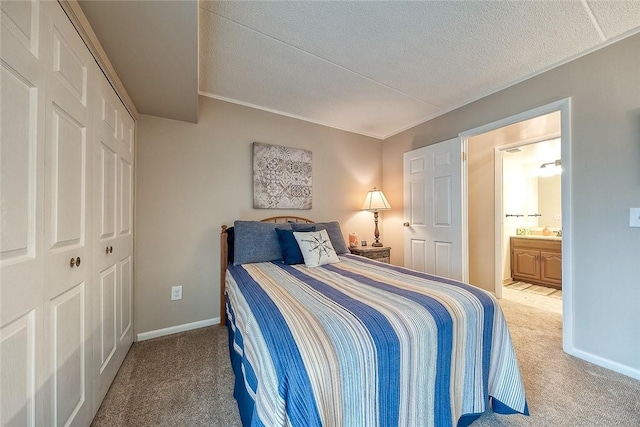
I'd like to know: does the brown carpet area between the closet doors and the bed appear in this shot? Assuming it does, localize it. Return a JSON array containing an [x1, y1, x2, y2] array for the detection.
[[92, 326, 240, 427]]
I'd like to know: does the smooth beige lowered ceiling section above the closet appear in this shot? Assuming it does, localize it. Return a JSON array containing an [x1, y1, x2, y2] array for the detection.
[[78, 0, 198, 123]]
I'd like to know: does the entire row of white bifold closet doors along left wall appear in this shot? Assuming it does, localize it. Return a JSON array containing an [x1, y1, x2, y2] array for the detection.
[[0, 0, 134, 426]]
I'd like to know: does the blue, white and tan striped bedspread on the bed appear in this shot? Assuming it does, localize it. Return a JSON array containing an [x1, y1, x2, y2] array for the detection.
[[227, 255, 528, 427]]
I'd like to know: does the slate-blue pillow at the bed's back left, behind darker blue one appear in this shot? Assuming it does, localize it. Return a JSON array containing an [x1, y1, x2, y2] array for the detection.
[[233, 221, 291, 265]]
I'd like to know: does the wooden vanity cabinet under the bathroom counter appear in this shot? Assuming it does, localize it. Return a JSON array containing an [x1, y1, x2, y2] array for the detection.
[[511, 237, 562, 289]]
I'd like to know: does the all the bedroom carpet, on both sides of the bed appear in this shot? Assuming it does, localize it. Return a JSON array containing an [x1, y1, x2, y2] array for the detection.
[[92, 299, 640, 427]]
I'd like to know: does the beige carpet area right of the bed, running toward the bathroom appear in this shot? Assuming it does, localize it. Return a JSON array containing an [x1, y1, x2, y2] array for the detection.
[[473, 299, 640, 427]]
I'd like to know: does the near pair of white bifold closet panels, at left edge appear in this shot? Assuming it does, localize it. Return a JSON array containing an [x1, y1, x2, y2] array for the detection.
[[0, 1, 97, 426]]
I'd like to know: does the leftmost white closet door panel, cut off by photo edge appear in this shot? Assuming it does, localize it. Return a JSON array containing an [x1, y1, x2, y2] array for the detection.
[[0, 1, 45, 426]]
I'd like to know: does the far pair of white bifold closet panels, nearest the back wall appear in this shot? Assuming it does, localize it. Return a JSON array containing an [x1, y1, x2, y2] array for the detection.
[[93, 78, 133, 405]]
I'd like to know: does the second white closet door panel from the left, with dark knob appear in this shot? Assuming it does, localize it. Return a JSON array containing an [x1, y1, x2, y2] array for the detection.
[[41, 2, 97, 426]]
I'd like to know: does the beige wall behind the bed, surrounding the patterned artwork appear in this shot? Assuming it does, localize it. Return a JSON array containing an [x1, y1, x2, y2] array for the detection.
[[135, 97, 384, 333]]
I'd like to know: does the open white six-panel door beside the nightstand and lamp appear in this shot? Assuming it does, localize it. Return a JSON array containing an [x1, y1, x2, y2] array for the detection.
[[404, 138, 463, 280]]
